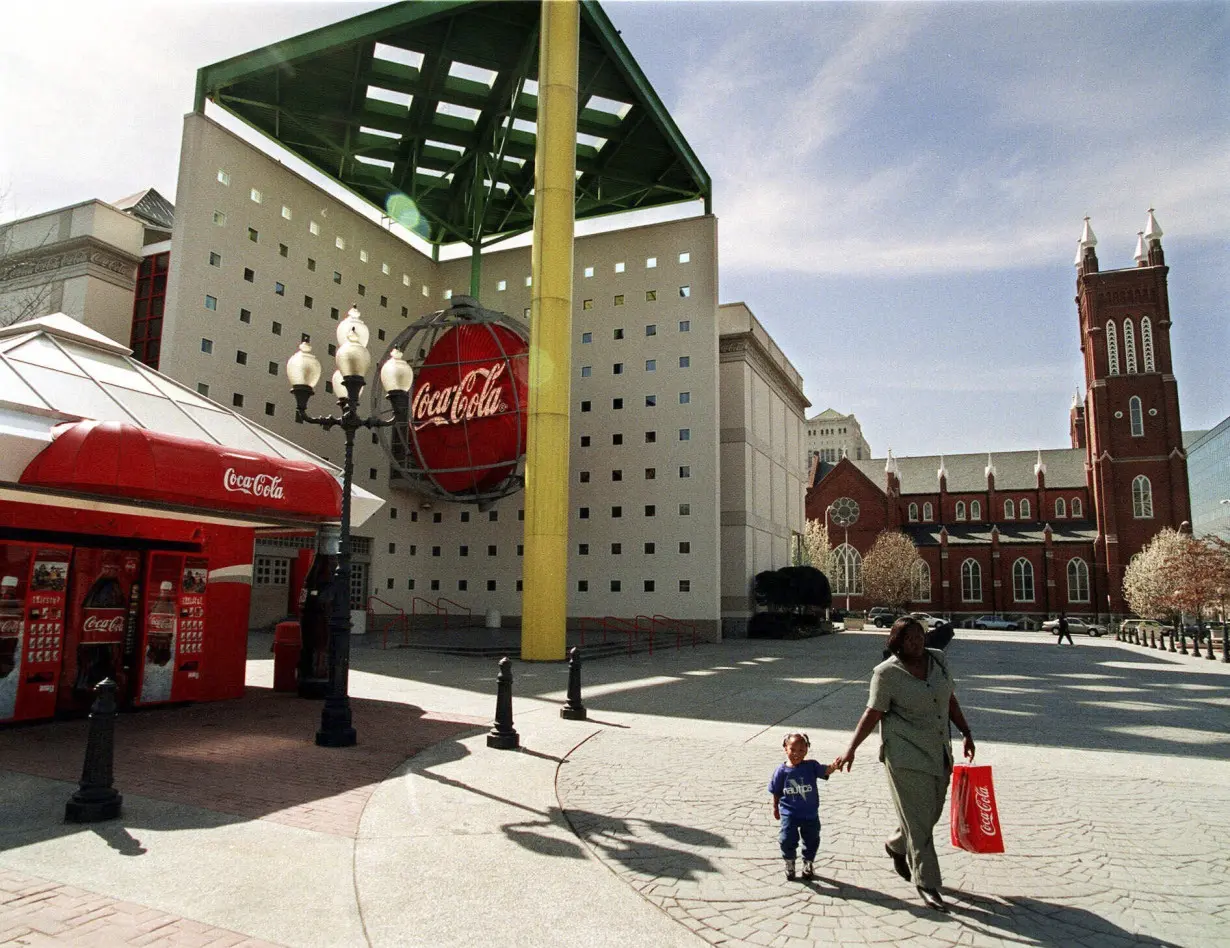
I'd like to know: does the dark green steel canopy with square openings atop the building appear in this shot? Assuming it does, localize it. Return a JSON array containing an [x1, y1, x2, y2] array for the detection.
[[196, 0, 712, 247]]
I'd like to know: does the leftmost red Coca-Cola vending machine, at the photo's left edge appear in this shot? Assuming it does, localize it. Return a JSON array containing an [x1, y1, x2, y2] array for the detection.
[[0, 543, 70, 722]]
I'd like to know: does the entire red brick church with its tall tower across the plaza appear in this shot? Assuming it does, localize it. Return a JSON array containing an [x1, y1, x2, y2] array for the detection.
[[807, 209, 1192, 621]]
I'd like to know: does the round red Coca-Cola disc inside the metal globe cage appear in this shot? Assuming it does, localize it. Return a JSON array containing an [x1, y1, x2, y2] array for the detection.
[[408, 323, 529, 494]]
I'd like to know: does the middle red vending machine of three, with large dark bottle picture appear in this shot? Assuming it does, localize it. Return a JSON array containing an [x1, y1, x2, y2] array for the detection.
[[57, 547, 141, 711]]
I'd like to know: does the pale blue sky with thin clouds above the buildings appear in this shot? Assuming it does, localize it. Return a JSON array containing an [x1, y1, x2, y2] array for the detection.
[[0, 0, 1230, 456]]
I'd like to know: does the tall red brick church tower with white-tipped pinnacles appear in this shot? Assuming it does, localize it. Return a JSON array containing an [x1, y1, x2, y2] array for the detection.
[[1074, 208, 1192, 614]]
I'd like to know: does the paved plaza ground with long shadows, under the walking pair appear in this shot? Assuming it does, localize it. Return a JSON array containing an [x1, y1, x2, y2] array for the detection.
[[0, 631, 1230, 947]]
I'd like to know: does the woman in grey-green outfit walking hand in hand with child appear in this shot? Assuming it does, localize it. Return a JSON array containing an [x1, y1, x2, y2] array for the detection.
[[833, 616, 974, 912]]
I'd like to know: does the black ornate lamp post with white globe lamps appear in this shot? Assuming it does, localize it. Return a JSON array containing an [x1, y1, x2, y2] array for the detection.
[[287, 306, 415, 748]]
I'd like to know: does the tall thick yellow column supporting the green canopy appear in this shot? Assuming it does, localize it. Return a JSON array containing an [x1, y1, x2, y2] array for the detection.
[[522, 0, 581, 662]]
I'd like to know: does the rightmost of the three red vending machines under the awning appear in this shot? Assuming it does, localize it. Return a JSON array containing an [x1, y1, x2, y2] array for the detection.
[[133, 552, 209, 705]]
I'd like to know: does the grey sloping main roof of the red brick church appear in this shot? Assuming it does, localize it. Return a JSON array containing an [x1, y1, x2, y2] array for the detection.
[[846, 448, 1086, 494]]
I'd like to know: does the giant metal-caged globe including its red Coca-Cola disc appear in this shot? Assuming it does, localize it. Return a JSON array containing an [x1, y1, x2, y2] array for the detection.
[[371, 296, 529, 503]]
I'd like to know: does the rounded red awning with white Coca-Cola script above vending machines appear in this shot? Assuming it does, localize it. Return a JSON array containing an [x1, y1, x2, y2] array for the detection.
[[21, 422, 342, 520]]
